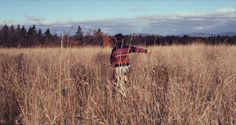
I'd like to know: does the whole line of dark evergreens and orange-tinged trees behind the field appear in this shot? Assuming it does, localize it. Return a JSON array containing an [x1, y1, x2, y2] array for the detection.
[[0, 25, 236, 48]]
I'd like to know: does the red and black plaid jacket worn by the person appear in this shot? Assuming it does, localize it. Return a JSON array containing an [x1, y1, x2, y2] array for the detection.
[[110, 46, 147, 67]]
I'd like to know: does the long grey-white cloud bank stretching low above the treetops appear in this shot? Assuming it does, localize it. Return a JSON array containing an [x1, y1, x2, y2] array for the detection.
[[2, 8, 236, 35]]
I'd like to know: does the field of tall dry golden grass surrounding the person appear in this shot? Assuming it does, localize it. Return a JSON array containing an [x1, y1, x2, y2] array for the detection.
[[0, 44, 236, 125]]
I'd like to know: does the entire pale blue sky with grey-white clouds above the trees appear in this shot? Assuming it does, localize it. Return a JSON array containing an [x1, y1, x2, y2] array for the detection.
[[0, 0, 236, 35]]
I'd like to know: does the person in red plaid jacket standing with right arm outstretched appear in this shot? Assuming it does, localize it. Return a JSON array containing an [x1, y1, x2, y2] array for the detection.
[[110, 33, 147, 95]]
